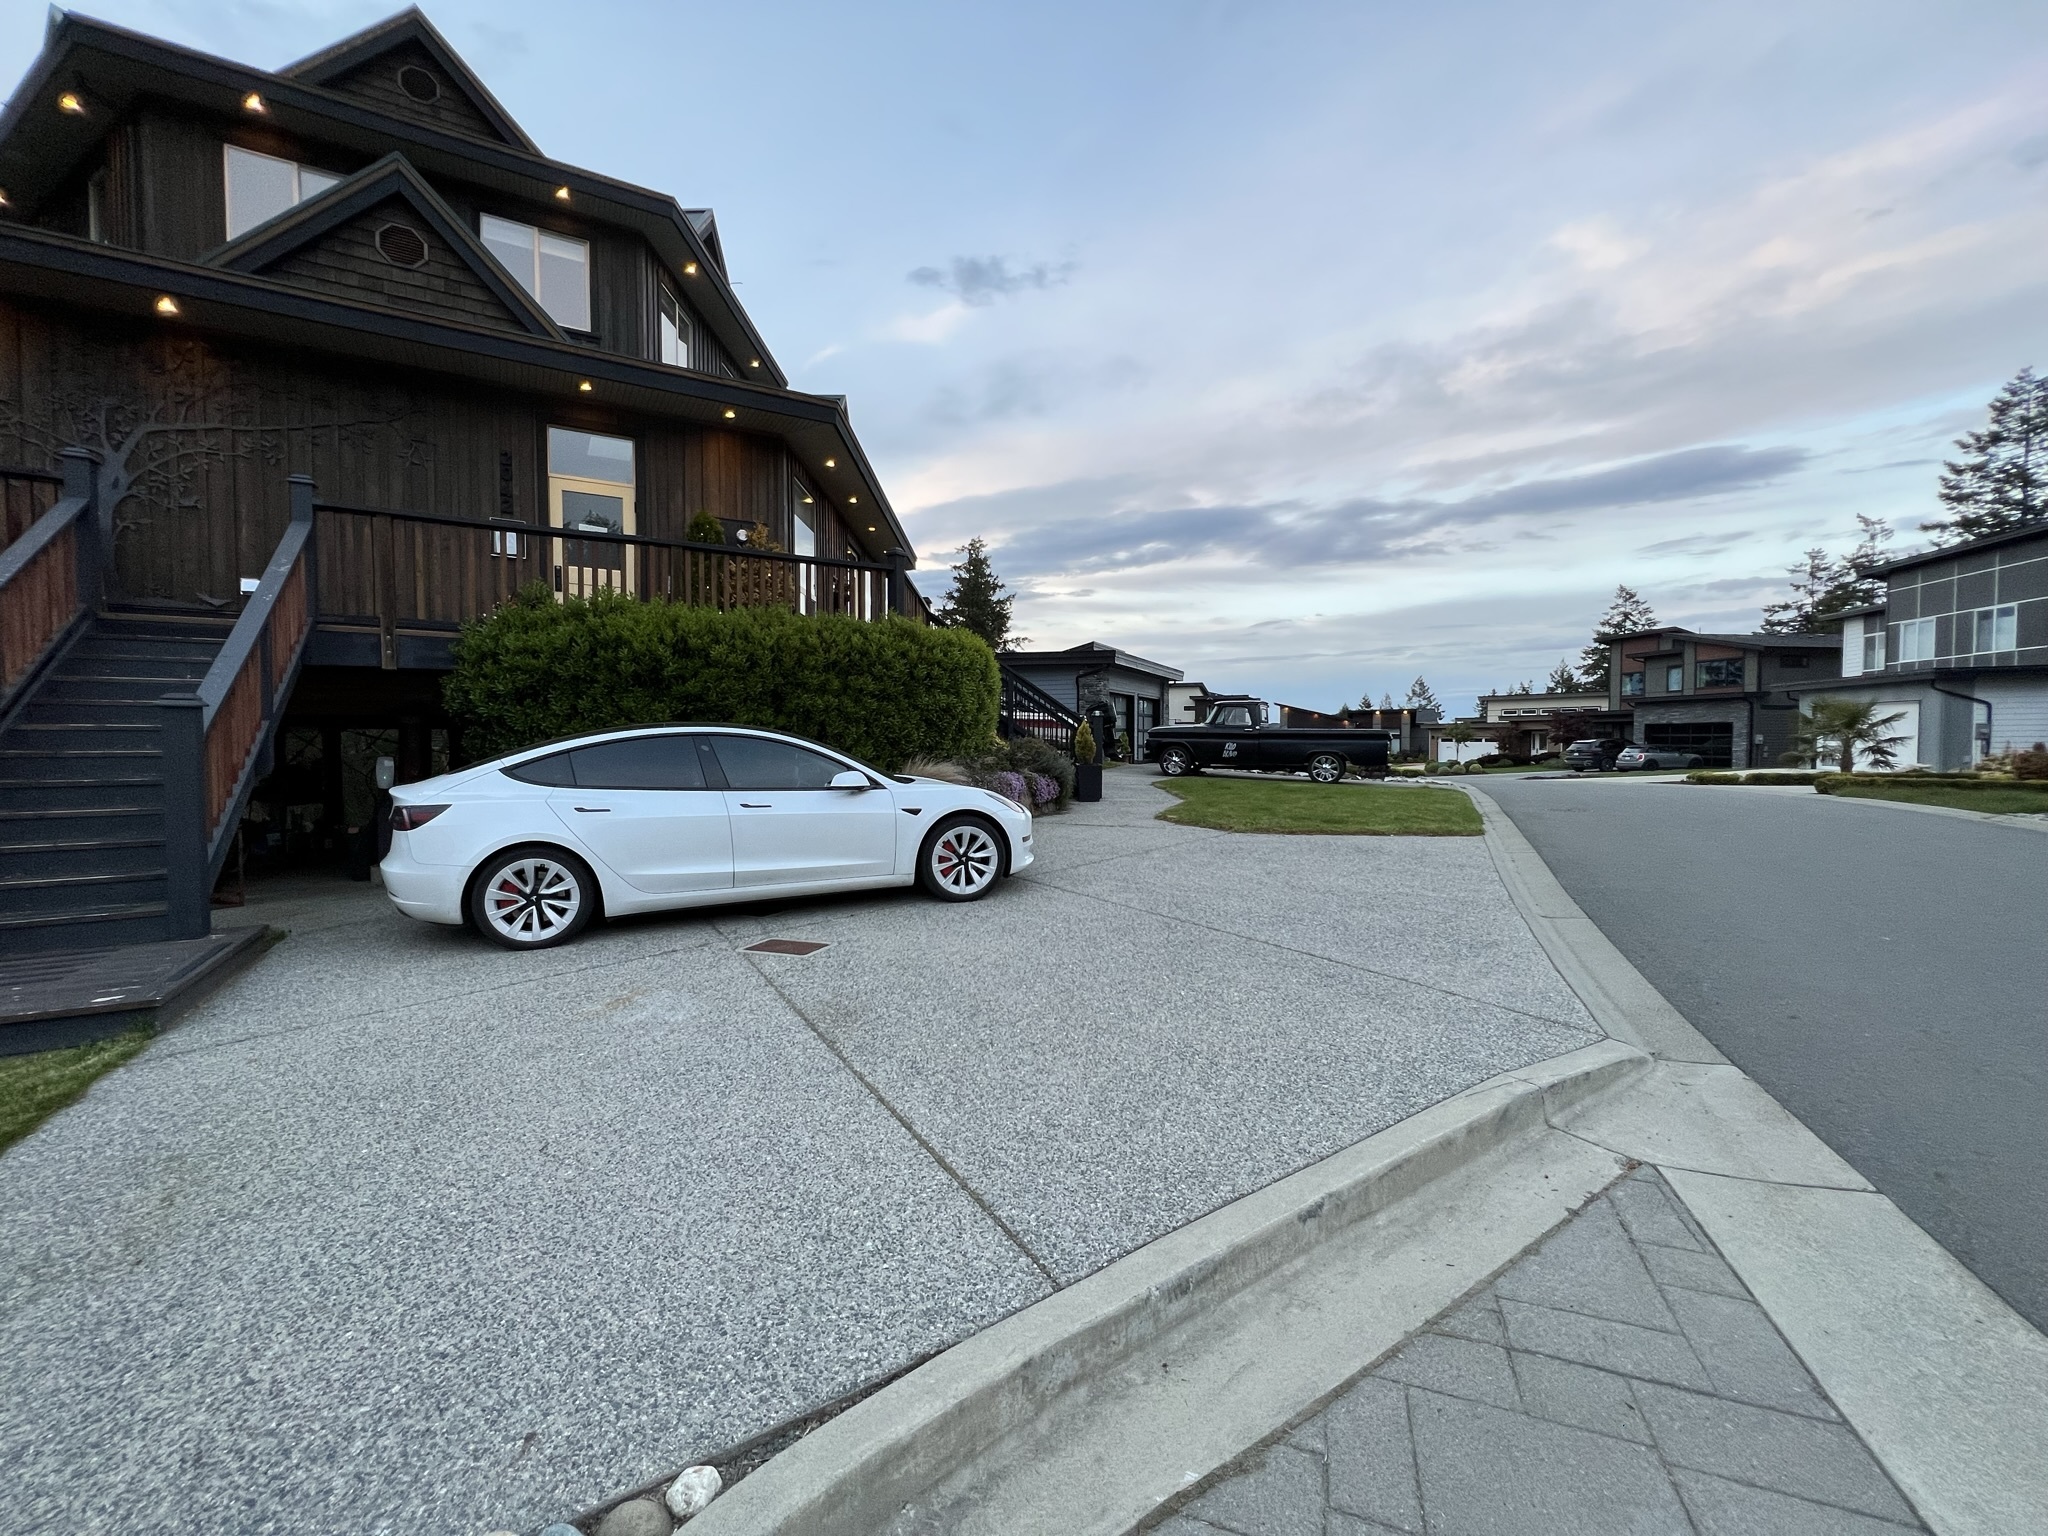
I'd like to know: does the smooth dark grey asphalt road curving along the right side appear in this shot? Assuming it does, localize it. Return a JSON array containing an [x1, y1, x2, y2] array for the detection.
[[1485, 776, 2048, 1329]]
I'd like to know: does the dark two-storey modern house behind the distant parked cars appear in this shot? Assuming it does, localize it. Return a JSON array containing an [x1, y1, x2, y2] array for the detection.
[[1606, 627, 1841, 768]]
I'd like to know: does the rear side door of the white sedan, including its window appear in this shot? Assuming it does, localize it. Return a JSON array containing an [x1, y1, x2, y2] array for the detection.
[[547, 735, 733, 895]]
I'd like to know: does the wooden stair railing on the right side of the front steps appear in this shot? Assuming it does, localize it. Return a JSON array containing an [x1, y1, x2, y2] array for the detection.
[[158, 475, 319, 938]]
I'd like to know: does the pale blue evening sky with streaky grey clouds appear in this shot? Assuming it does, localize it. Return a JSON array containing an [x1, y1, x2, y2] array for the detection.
[[0, 0, 2048, 711]]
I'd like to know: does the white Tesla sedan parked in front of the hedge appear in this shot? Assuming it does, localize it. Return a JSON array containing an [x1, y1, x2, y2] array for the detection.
[[381, 725, 1032, 950]]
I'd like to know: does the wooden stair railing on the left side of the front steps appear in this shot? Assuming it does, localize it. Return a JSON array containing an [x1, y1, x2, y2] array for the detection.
[[0, 449, 104, 719]]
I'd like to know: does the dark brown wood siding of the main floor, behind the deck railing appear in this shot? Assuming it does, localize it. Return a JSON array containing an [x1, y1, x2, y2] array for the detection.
[[0, 301, 848, 618]]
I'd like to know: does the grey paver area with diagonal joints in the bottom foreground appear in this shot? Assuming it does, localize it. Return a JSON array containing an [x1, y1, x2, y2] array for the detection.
[[1153, 1167, 1925, 1536]]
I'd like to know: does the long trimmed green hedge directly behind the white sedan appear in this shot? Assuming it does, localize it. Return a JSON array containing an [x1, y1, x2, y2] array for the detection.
[[442, 584, 1001, 770]]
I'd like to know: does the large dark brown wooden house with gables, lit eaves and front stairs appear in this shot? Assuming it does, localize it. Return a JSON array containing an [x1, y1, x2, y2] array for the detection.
[[0, 10, 922, 954]]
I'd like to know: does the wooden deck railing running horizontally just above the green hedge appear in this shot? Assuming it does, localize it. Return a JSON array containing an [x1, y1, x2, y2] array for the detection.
[[315, 502, 930, 668]]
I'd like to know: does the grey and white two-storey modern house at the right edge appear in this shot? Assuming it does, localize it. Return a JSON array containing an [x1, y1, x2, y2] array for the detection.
[[1796, 524, 2048, 770]]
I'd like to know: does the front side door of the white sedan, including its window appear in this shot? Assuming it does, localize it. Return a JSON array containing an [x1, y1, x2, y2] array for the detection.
[[711, 735, 903, 887]]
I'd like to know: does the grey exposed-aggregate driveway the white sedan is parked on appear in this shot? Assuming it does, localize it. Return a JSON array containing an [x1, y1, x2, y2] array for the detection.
[[0, 770, 1595, 1536]]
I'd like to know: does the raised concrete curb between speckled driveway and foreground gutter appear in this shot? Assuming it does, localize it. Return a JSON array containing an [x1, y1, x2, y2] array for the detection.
[[692, 1040, 1649, 1536]]
